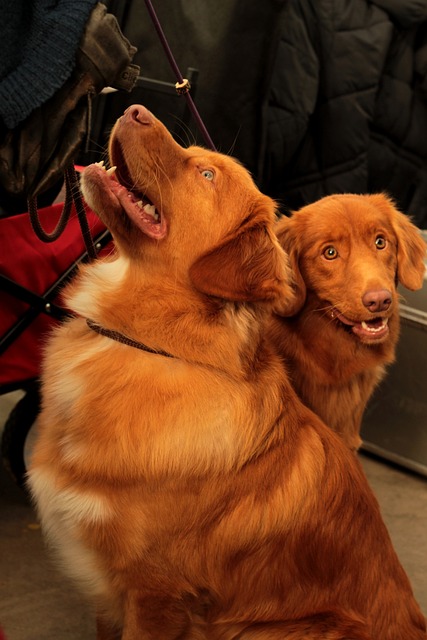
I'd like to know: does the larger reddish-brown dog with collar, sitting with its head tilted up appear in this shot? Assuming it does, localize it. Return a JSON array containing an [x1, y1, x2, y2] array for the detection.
[[29, 105, 427, 640]]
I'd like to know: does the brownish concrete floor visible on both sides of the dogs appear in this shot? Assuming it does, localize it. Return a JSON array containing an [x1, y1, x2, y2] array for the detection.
[[0, 394, 427, 640]]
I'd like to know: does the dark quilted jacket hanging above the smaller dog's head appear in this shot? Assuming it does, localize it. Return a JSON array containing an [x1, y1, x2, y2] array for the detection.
[[259, 0, 427, 228]]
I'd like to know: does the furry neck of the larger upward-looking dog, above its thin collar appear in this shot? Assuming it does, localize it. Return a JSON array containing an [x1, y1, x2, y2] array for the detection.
[[64, 259, 268, 376]]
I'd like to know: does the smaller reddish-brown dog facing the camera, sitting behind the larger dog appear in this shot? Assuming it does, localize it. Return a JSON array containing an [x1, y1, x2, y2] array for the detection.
[[271, 194, 426, 449]]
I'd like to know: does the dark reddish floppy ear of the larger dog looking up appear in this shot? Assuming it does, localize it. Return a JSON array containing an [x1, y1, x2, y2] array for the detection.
[[190, 216, 300, 311]]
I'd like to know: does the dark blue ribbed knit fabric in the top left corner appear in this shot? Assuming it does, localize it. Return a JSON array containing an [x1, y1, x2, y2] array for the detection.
[[0, 0, 96, 129]]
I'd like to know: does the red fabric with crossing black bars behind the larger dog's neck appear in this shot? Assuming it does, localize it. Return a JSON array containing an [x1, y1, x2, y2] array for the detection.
[[0, 203, 112, 393]]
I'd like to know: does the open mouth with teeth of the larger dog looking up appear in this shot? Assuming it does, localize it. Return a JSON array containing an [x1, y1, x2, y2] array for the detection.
[[95, 145, 167, 240]]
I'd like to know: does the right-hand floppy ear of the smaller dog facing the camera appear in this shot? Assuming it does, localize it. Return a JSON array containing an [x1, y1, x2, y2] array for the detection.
[[372, 194, 426, 291]]
